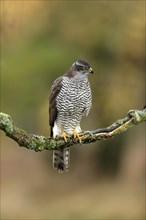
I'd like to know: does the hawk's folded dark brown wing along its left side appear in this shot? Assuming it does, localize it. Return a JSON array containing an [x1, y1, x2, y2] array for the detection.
[[49, 77, 62, 137]]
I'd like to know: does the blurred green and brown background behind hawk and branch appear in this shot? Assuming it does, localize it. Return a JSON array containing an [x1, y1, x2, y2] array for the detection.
[[1, 0, 145, 220]]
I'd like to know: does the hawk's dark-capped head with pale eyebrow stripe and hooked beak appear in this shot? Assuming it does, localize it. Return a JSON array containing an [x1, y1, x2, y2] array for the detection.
[[65, 60, 93, 78]]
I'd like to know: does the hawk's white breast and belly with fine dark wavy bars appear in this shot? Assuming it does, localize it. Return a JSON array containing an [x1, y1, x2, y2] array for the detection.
[[53, 77, 92, 137]]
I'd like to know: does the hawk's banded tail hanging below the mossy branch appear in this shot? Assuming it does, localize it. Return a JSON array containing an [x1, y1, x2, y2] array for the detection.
[[53, 148, 70, 173]]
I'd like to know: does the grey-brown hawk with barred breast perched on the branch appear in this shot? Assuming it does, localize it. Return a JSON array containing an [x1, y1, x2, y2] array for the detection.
[[49, 60, 93, 172]]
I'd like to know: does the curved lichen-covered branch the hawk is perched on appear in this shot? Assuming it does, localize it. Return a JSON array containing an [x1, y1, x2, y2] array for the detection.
[[0, 108, 146, 151]]
